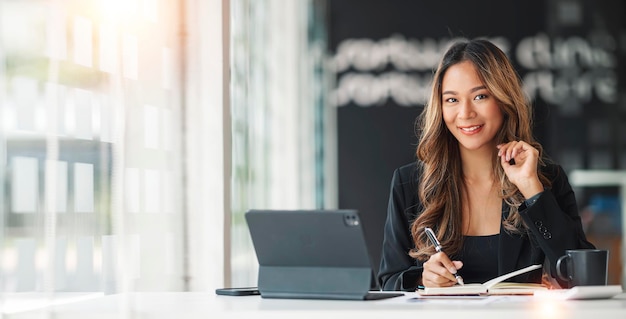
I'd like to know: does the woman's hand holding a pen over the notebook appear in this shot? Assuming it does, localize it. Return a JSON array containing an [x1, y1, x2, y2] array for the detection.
[[422, 252, 463, 287]]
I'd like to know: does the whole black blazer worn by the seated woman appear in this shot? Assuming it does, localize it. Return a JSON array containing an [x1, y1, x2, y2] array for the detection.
[[377, 163, 594, 291]]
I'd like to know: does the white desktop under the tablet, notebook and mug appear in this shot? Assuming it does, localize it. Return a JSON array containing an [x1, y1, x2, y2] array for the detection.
[[2, 292, 626, 319]]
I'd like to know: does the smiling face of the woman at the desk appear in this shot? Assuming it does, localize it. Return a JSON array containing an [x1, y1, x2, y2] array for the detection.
[[441, 61, 504, 154]]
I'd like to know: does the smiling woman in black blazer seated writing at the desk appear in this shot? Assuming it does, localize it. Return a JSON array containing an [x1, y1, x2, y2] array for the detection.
[[378, 39, 593, 291]]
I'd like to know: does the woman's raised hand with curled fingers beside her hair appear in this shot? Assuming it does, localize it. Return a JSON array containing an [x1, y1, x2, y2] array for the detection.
[[497, 141, 543, 198]]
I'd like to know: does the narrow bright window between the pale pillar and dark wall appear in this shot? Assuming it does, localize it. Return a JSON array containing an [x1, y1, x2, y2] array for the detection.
[[231, 0, 336, 286]]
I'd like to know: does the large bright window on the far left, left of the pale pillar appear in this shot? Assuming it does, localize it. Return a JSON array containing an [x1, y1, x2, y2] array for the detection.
[[0, 0, 184, 311]]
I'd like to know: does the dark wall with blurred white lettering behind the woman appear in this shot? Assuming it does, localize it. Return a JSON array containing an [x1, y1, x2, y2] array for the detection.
[[328, 0, 626, 288]]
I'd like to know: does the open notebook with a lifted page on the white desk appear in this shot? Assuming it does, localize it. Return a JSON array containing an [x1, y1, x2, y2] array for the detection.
[[417, 265, 548, 295]]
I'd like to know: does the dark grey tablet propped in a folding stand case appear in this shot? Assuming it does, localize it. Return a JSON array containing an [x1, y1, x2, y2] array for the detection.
[[245, 210, 403, 300]]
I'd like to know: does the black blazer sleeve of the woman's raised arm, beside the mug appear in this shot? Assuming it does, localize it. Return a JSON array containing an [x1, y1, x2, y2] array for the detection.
[[520, 165, 595, 286]]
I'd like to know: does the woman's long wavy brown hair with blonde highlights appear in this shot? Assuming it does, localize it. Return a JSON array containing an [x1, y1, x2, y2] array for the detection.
[[409, 39, 550, 261]]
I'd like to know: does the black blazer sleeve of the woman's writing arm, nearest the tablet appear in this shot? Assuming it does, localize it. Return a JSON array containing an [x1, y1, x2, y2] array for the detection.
[[377, 165, 422, 291]]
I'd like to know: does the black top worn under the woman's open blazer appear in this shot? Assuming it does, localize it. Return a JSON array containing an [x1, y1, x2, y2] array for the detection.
[[454, 234, 500, 284]]
